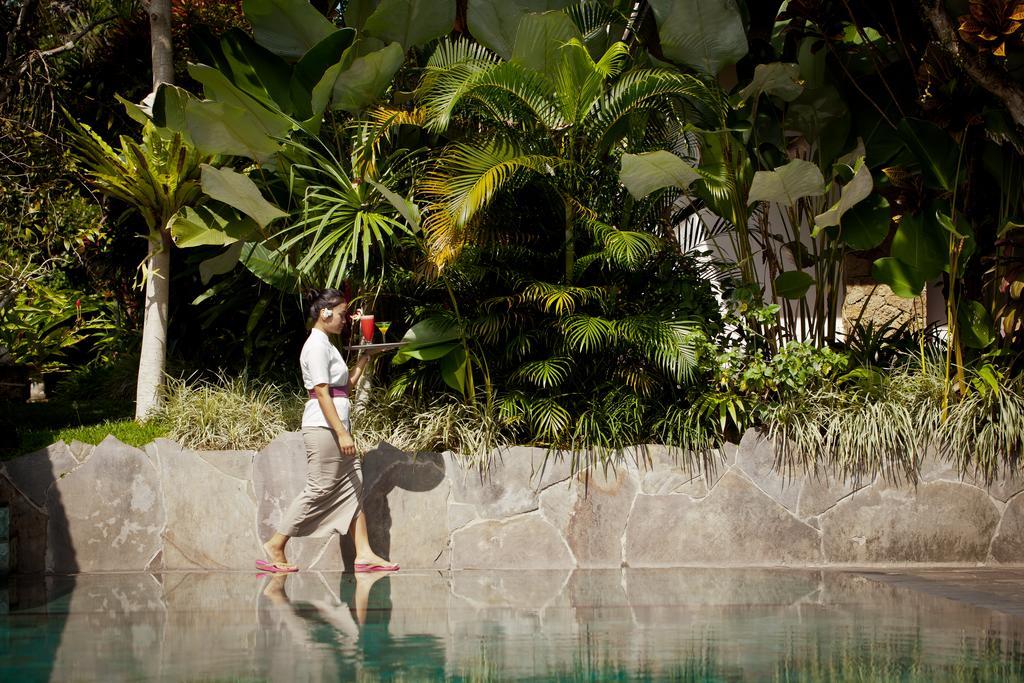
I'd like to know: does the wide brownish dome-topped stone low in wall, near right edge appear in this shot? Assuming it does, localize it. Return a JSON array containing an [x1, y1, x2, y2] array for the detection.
[[820, 481, 999, 563]]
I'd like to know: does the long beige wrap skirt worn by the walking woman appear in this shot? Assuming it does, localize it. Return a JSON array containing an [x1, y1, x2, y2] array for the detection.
[[278, 427, 362, 537]]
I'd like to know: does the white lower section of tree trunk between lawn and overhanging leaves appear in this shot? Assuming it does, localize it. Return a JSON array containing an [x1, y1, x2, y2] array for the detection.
[[135, 231, 171, 420]]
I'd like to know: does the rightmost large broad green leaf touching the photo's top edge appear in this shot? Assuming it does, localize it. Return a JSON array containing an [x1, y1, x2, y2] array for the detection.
[[648, 0, 748, 76]]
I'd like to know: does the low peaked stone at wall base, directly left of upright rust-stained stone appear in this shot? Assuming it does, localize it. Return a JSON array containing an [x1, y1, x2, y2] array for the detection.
[[452, 512, 575, 569]]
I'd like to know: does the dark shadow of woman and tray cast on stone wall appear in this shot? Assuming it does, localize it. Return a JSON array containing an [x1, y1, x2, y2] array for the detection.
[[341, 442, 446, 571]]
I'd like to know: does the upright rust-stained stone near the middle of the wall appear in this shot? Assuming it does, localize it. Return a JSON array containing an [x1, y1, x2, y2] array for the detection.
[[560, 465, 639, 567]]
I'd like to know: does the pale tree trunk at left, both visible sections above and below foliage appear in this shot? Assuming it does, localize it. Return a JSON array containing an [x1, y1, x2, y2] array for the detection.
[[135, 0, 174, 420]]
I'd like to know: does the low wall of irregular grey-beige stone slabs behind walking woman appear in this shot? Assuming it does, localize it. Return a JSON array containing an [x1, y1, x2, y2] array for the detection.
[[0, 431, 1024, 573]]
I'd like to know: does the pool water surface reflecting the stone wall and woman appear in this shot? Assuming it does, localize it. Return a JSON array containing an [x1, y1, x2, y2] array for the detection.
[[0, 569, 1024, 681]]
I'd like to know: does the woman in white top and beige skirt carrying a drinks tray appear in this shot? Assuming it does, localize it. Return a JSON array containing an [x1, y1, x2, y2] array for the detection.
[[256, 289, 398, 572]]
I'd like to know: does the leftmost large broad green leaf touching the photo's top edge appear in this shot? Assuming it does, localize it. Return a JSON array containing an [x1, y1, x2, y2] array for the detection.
[[242, 0, 338, 60]]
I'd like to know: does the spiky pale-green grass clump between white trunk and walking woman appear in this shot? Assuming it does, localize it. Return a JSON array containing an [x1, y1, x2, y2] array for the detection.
[[154, 375, 303, 451]]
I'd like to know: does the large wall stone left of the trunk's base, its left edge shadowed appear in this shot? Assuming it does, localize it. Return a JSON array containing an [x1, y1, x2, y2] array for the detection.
[[46, 436, 165, 573]]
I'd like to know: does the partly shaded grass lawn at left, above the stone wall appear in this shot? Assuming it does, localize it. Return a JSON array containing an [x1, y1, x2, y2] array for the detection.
[[0, 399, 167, 460]]
